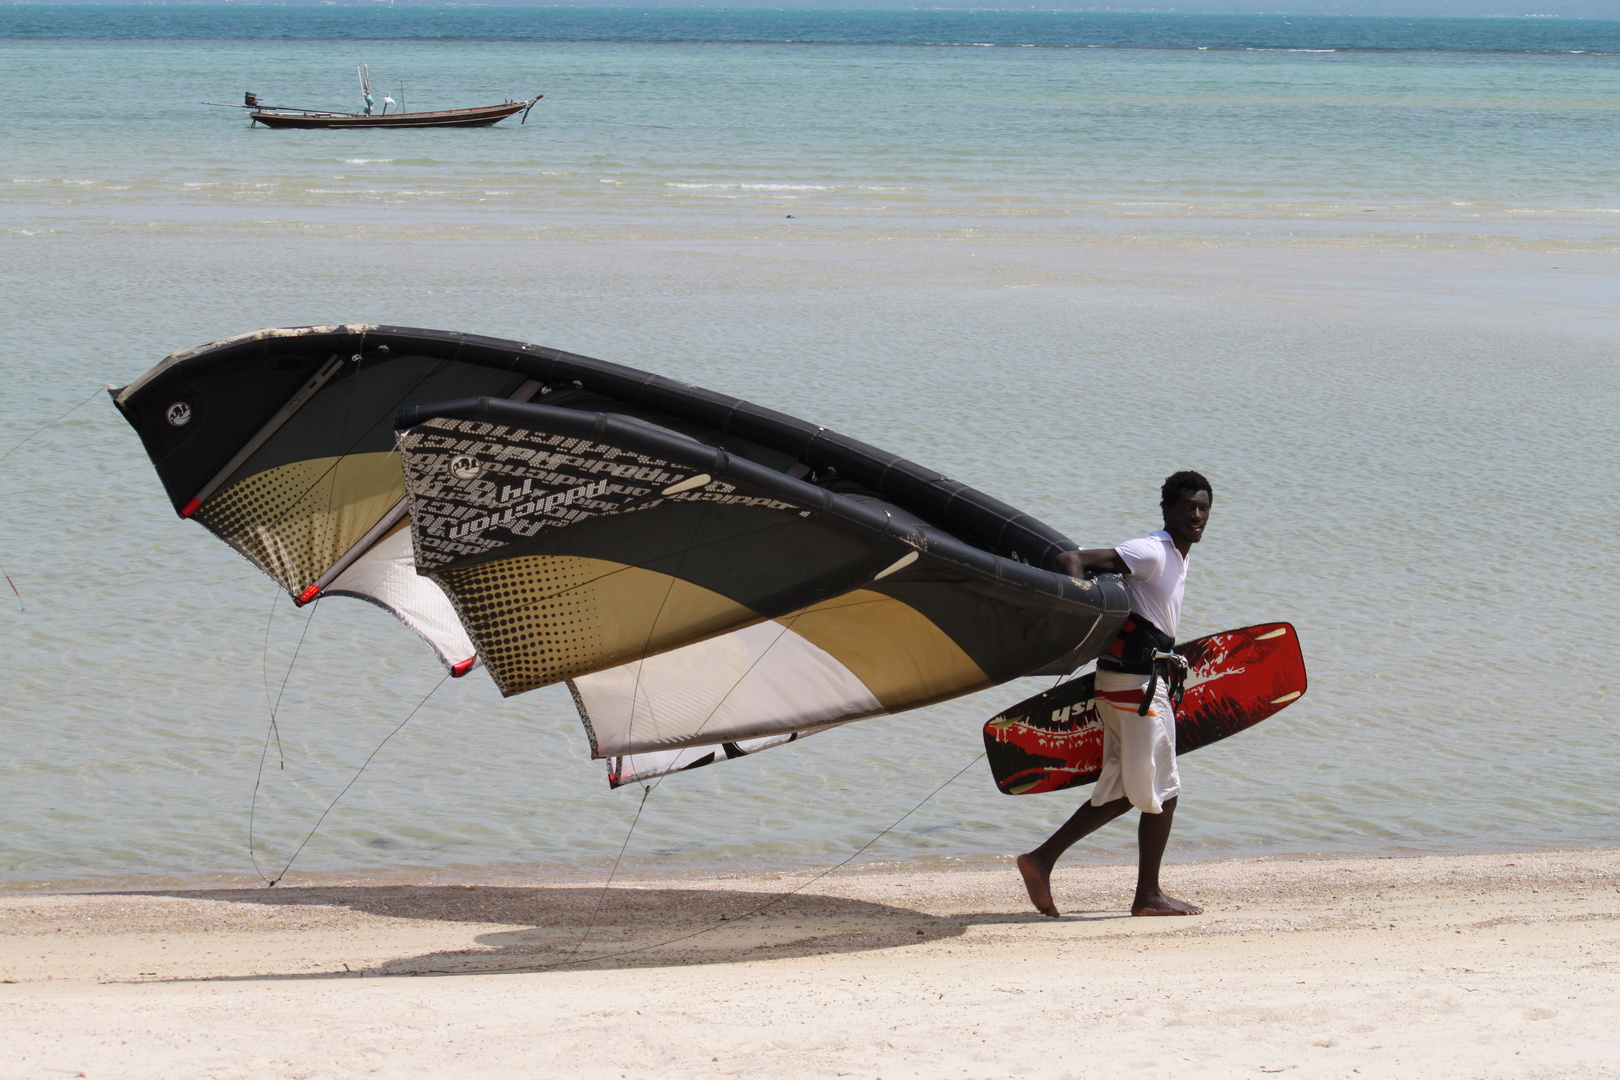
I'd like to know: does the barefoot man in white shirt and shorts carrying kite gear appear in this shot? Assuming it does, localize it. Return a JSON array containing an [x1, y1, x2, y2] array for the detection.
[[1017, 471, 1215, 918]]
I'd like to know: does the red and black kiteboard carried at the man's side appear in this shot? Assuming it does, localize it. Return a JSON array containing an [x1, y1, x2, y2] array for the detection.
[[985, 622, 1306, 795]]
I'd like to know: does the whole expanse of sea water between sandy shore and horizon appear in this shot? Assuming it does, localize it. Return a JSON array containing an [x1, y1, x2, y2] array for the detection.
[[0, 5, 1620, 887]]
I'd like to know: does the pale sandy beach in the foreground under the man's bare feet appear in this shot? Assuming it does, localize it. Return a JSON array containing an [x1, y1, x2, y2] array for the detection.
[[0, 850, 1620, 1078]]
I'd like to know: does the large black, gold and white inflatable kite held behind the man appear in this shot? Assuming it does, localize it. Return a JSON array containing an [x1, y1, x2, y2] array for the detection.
[[113, 325, 1129, 785]]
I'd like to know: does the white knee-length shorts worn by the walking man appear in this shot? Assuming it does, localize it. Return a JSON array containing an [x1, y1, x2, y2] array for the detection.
[[1092, 670, 1181, 814]]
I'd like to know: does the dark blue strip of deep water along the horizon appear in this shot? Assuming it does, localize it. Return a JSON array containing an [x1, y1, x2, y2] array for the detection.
[[0, 3, 1620, 53]]
